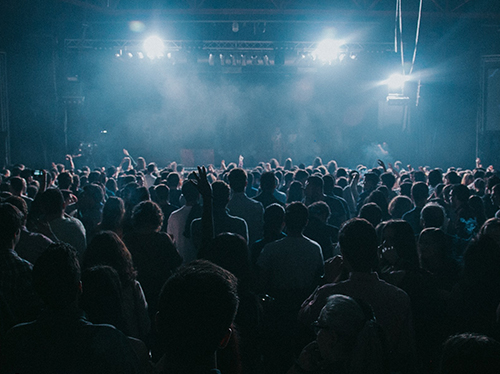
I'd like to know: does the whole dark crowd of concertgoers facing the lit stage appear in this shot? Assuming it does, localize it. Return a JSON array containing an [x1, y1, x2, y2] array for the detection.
[[0, 150, 500, 374]]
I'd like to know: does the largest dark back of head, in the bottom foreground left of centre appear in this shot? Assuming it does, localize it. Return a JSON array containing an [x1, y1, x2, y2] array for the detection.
[[157, 260, 238, 363]]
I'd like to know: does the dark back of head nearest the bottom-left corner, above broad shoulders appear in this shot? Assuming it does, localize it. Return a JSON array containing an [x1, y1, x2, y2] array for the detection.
[[33, 243, 80, 309]]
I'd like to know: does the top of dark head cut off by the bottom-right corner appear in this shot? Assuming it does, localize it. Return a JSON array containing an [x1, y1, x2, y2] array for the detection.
[[441, 333, 500, 374]]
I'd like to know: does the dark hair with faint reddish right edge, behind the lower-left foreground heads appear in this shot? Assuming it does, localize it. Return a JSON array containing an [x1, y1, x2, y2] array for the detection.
[[83, 231, 137, 287]]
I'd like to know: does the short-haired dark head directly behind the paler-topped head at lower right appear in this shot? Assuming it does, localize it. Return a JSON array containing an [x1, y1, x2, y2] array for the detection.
[[339, 218, 378, 272]]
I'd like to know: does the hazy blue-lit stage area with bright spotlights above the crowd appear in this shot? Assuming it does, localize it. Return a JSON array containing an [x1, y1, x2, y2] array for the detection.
[[0, 0, 500, 167]]
